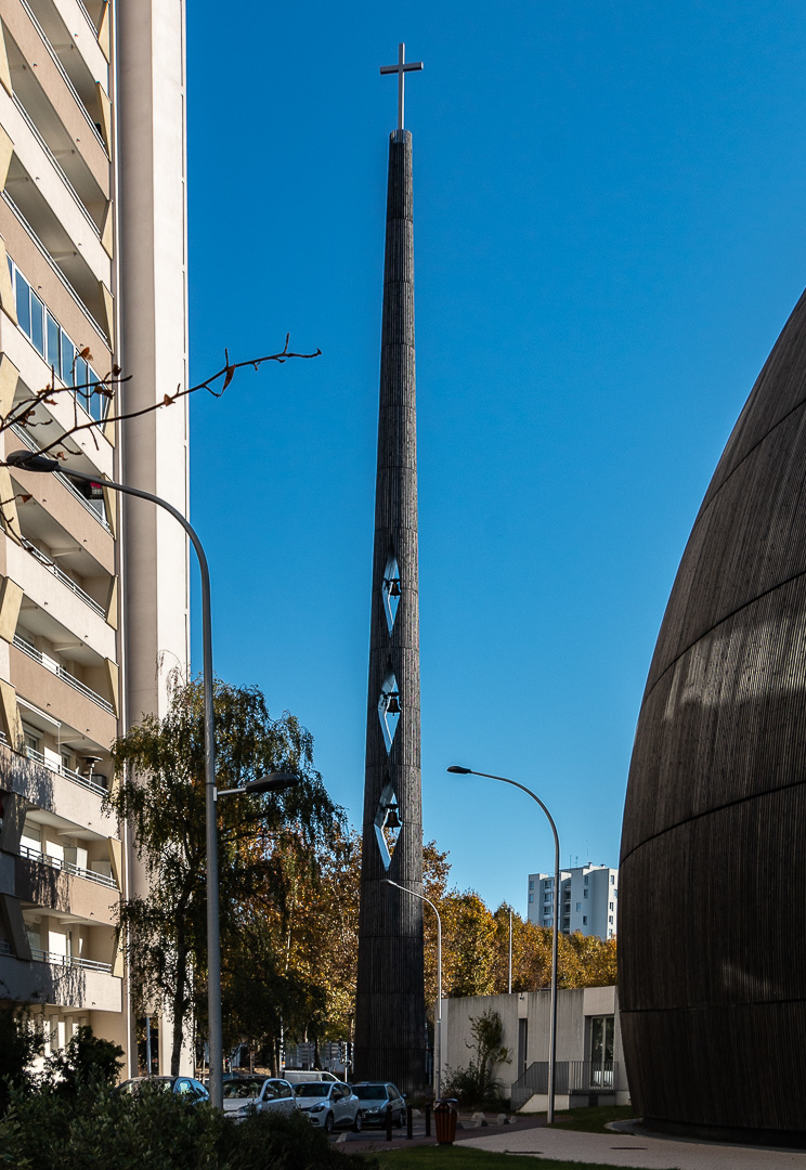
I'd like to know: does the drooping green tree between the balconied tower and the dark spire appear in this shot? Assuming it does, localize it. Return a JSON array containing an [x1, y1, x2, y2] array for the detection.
[[105, 681, 340, 1074]]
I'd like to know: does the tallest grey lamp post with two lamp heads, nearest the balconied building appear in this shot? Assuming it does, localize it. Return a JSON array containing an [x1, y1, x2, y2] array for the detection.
[[6, 450, 285, 1109]]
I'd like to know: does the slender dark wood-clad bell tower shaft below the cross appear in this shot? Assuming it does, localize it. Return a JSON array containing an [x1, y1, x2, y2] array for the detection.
[[354, 131, 426, 1092]]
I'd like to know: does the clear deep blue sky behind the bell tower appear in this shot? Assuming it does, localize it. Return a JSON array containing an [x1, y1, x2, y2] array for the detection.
[[188, 0, 806, 913]]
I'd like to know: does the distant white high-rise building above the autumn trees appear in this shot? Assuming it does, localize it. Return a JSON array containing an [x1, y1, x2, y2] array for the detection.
[[526, 861, 619, 938]]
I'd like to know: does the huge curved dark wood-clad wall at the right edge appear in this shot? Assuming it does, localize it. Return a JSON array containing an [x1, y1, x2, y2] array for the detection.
[[619, 287, 806, 1137]]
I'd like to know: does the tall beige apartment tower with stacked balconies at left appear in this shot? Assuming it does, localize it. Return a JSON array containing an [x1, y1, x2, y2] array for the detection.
[[0, 0, 188, 1073]]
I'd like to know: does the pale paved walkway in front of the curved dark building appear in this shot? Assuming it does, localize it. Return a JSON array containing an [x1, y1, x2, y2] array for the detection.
[[455, 1126, 806, 1170]]
